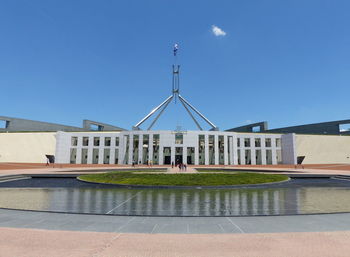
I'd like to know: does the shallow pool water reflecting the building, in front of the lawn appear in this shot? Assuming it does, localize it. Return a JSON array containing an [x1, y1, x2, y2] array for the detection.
[[0, 187, 350, 216]]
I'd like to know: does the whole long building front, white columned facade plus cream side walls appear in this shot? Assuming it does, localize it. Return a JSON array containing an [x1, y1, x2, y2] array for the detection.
[[0, 117, 350, 165]]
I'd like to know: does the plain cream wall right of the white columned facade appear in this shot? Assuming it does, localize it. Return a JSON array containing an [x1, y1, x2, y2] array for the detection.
[[296, 135, 350, 164]]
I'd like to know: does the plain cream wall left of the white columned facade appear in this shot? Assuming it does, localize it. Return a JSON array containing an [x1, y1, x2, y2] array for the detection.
[[0, 132, 56, 163]]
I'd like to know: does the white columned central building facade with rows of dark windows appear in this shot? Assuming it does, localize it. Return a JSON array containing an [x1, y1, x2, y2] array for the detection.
[[55, 130, 296, 165]]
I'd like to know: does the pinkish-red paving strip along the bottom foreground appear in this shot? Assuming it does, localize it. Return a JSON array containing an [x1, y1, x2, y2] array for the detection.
[[0, 228, 350, 257]]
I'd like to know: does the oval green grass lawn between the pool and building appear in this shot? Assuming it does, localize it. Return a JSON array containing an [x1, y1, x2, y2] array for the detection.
[[78, 172, 288, 186]]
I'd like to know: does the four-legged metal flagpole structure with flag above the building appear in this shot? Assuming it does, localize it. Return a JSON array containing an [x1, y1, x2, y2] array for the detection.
[[132, 44, 219, 130]]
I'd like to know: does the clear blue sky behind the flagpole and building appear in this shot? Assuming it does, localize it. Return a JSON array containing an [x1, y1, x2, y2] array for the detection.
[[0, 0, 350, 130]]
